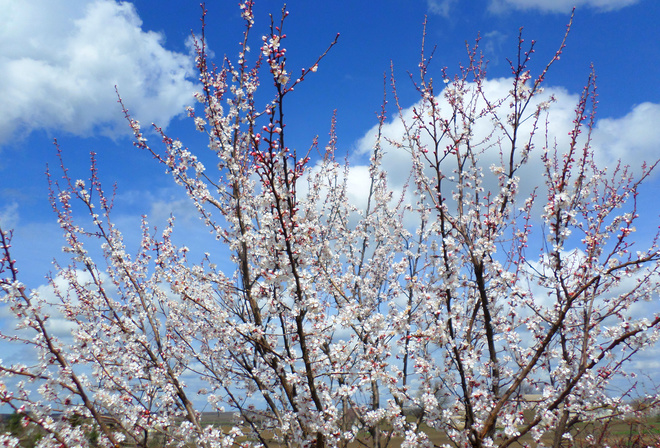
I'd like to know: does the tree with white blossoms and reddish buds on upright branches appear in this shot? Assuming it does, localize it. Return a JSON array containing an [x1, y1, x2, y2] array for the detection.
[[0, 1, 660, 448]]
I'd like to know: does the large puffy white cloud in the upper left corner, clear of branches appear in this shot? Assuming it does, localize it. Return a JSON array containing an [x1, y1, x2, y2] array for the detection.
[[0, 0, 194, 144]]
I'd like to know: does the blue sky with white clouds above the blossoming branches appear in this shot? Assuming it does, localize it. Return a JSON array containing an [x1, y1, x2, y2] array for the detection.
[[0, 0, 660, 360]]
